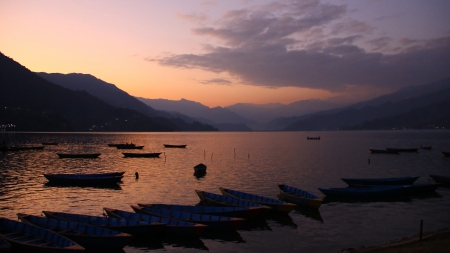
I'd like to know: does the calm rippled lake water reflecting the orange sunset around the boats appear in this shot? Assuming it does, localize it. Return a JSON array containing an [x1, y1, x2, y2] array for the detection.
[[0, 131, 450, 252]]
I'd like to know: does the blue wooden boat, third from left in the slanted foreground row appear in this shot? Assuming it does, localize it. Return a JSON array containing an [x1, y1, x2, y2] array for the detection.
[[42, 211, 166, 235]]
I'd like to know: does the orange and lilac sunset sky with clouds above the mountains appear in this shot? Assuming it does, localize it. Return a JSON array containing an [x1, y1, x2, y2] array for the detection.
[[0, 0, 450, 107]]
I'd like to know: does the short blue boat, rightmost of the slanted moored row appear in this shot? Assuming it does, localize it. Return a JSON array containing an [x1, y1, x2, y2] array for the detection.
[[278, 183, 323, 208]]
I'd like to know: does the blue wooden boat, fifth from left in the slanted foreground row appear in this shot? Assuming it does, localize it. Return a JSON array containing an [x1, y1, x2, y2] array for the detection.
[[131, 205, 246, 229]]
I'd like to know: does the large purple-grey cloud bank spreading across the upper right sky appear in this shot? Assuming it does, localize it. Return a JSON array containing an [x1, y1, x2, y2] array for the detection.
[[153, 0, 450, 92]]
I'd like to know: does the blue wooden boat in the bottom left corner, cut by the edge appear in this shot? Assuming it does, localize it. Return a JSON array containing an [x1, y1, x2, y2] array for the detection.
[[0, 215, 84, 253]]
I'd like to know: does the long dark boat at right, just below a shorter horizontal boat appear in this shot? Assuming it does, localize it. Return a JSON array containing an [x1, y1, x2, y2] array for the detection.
[[319, 185, 411, 198]]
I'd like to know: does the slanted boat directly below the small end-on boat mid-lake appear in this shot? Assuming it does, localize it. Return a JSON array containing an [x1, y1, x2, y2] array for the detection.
[[195, 190, 272, 213]]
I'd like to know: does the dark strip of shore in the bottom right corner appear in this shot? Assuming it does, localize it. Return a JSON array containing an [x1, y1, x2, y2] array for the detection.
[[340, 229, 450, 253]]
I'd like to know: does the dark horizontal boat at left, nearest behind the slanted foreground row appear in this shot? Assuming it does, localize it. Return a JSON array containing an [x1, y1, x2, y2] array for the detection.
[[44, 172, 125, 185]]
